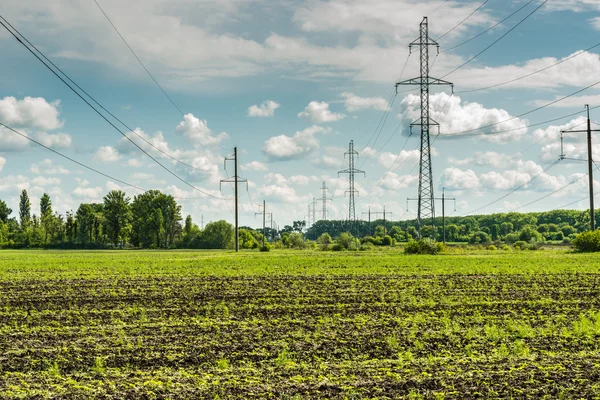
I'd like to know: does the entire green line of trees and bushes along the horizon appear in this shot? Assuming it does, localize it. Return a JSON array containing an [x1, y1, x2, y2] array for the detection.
[[0, 186, 598, 249]]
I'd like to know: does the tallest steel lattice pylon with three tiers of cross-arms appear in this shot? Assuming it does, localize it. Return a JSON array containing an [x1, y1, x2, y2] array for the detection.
[[396, 17, 454, 237]]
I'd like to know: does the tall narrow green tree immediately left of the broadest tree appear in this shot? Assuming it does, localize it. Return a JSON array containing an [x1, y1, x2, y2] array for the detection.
[[104, 190, 132, 247]]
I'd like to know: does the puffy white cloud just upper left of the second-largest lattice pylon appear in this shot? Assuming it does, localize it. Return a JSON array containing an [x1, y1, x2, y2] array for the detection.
[[263, 125, 329, 160]]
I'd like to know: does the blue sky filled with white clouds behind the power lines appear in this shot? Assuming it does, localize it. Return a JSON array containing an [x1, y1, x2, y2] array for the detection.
[[0, 0, 600, 226]]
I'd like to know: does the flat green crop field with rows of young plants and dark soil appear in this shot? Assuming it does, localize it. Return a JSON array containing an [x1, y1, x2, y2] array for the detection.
[[0, 250, 600, 399]]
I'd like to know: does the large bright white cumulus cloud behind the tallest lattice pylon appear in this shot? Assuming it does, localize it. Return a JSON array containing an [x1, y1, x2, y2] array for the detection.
[[402, 93, 528, 143]]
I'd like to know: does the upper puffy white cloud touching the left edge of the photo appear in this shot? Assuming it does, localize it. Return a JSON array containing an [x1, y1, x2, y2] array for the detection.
[[0, 96, 63, 130]]
